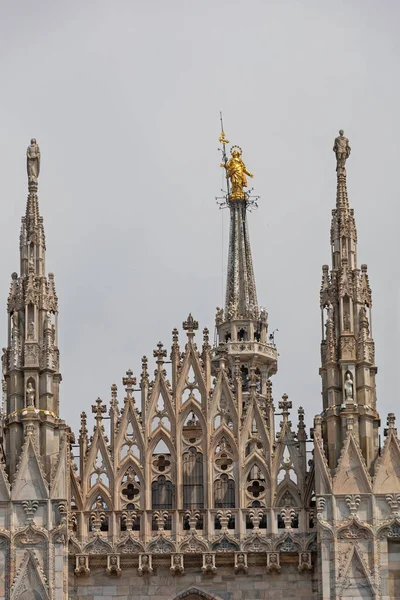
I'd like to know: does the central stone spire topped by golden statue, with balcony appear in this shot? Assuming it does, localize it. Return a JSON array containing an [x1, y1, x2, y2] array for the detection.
[[216, 131, 277, 404]]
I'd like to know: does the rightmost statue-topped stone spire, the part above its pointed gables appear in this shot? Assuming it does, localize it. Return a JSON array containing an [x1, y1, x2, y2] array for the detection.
[[320, 130, 379, 469]]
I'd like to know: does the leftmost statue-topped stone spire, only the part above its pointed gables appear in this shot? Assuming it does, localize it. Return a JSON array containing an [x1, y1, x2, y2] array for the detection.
[[2, 139, 65, 478]]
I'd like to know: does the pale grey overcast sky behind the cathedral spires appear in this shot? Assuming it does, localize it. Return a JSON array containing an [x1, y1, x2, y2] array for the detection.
[[0, 0, 400, 440]]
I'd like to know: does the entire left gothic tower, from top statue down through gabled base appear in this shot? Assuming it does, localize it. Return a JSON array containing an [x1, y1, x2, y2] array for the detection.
[[0, 139, 72, 600]]
